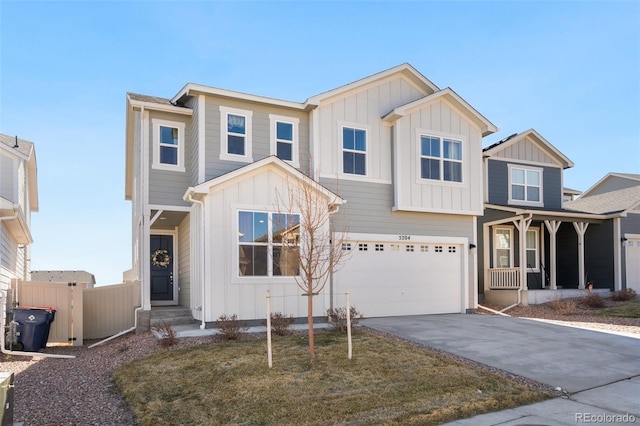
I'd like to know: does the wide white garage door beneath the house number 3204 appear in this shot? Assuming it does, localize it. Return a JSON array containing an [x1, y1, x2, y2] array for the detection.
[[334, 236, 466, 317]]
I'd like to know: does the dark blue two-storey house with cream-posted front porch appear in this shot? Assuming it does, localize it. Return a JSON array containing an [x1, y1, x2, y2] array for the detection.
[[478, 129, 637, 304]]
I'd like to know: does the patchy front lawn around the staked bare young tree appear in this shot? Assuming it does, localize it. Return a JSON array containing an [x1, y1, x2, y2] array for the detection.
[[114, 332, 551, 425]]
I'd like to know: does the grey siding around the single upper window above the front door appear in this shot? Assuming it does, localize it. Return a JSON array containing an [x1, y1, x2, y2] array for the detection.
[[147, 111, 197, 206]]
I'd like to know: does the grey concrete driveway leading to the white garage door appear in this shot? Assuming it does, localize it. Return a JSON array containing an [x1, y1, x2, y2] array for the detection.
[[360, 314, 640, 425]]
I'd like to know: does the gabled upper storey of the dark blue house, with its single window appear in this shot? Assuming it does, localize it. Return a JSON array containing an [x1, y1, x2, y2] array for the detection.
[[483, 129, 573, 210]]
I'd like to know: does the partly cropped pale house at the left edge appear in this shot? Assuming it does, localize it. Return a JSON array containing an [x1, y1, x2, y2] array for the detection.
[[0, 134, 38, 290]]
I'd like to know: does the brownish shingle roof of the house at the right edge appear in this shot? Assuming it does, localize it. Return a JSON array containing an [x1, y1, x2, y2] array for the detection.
[[563, 184, 640, 214]]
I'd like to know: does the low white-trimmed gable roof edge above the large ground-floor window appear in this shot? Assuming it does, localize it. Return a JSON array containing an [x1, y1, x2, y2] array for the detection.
[[182, 155, 346, 205]]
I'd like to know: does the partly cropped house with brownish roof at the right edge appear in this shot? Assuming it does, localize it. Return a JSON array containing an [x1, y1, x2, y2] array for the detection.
[[565, 173, 640, 293]]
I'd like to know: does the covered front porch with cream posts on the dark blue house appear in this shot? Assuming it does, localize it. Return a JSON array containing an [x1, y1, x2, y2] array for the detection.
[[479, 206, 615, 305]]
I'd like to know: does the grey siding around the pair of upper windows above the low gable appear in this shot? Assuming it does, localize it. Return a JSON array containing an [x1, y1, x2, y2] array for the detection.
[[205, 96, 309, 180]]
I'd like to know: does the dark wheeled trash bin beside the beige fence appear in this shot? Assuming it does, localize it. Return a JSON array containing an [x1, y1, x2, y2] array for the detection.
[[13, 307, 56, 352]]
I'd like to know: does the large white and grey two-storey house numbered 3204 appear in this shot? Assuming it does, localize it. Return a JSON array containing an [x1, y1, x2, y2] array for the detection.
[[125, 64, 497, 326]]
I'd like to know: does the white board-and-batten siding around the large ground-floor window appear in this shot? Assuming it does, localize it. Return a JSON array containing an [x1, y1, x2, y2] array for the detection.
[[204, 169, 329, 322]]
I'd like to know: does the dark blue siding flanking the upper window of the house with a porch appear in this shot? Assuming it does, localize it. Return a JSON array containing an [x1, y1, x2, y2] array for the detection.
[[487, 159, 562, 209]]
